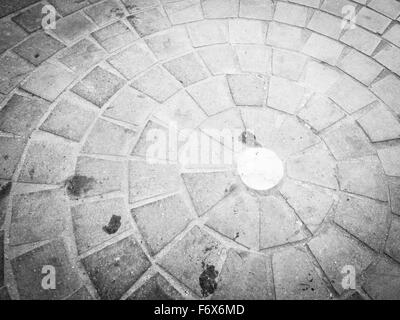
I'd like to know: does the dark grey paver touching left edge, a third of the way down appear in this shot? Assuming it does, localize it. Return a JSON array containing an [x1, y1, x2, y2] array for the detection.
[[0, 94, 50, 137]]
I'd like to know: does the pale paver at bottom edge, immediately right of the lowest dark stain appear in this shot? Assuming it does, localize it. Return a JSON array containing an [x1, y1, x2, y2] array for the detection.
[[212, 250, 273, 300]]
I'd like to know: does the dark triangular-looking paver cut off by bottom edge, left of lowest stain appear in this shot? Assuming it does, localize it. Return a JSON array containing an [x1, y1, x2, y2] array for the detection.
[[128, 273, 182, 301]]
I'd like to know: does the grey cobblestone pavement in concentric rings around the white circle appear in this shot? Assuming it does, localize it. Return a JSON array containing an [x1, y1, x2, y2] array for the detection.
[[0, 0, 400, 299]]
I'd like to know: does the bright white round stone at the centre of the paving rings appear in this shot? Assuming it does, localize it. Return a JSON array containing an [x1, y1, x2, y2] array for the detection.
[[237, 148, 284, 191]]
